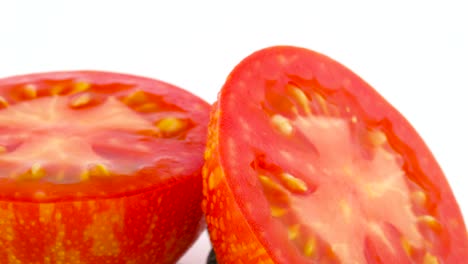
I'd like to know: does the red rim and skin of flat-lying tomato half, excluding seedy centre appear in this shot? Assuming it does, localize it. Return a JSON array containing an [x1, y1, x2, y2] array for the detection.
[[0, 71, 210, 264]]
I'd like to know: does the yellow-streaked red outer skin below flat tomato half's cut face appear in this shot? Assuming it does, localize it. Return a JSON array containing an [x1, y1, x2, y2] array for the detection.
[[0, 174, 204, 264]]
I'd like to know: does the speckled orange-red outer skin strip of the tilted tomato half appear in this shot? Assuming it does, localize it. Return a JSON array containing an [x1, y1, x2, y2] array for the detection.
[[202, 103, 273, 264]]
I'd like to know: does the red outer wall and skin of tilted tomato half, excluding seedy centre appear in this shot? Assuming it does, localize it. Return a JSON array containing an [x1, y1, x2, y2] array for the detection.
[[203, 47, 468, 263]]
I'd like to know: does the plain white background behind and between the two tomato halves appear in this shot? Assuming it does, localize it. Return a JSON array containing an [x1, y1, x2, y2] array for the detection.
[[0, 0, 468, 264]]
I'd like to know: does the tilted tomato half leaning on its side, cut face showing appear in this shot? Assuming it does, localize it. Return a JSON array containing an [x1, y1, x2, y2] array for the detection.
[[203, 46, 468, 264]]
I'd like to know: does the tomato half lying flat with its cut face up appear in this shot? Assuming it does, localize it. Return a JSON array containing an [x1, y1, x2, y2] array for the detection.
[[0, 72, 210, 264]]
